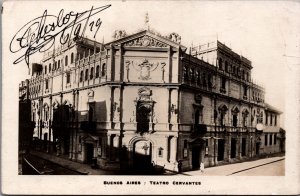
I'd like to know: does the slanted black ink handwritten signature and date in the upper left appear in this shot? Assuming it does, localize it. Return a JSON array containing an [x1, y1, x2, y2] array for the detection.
[[9, 5, 111, 66]]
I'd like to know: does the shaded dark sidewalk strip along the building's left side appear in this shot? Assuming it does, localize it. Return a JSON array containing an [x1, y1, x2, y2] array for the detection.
[[30, 150, 116, 175]]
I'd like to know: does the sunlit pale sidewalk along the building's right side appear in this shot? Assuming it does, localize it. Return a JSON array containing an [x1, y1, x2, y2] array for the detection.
[[178, 156, 285, 176]]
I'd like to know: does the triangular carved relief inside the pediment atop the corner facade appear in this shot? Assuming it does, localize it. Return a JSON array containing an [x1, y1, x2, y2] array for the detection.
[[124, 35, 168, 48]]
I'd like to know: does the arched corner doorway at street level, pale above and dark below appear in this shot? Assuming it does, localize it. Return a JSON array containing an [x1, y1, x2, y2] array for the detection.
[[133, 140, 152, 173]]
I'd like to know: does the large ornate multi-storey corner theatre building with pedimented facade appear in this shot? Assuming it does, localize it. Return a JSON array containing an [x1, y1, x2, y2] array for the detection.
[[19, 30, 284, 171]]
